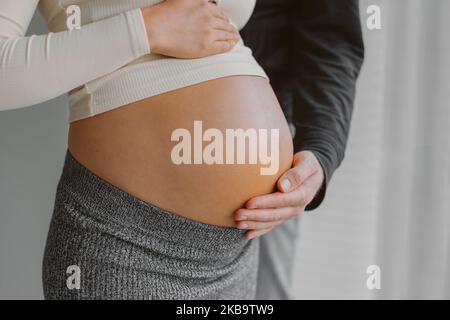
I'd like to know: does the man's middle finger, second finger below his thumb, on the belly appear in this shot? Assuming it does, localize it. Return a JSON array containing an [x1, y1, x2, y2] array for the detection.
[[234, 206, 304, 222]]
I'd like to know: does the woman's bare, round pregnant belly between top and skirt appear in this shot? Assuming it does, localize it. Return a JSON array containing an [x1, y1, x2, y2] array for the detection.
[[69, 76, 293, 226]]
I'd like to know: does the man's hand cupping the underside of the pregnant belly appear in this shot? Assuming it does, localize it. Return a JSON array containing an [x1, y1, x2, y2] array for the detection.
[[235, 151, 324, 239]]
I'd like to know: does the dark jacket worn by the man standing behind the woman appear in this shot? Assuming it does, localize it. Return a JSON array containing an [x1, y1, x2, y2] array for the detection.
[[241, 0, 364, 210]]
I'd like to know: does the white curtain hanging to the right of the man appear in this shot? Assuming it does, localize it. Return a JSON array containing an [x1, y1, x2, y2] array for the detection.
[[295, 0, 450, 299]]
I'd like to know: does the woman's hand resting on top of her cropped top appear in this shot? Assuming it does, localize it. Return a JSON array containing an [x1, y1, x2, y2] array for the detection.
[[142, 0, 240, 59]]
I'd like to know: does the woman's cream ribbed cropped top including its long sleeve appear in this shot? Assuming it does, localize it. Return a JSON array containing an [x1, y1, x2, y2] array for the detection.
[[0, 0, 267, 122]]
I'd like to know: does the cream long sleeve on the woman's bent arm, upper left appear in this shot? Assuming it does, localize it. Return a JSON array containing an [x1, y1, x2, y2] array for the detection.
[[0, 0, 150, 111]]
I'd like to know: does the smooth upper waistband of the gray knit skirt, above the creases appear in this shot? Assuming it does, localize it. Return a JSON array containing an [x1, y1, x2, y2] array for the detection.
[[58, 150, 248, 250]]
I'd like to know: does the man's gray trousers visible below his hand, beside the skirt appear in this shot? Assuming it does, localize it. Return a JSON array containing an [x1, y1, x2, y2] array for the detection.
[[256, 217, 300, 300]]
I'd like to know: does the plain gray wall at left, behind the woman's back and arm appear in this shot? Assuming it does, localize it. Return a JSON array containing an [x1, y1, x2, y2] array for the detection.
[[0, 10, 68, 299]]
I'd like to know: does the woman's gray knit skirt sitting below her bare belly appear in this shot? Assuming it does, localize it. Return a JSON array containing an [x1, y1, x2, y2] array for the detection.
[[43, 151, 259, 300]]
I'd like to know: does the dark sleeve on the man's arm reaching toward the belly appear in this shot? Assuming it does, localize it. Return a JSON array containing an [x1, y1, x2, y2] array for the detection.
[[289, 0, 364, 210]]
